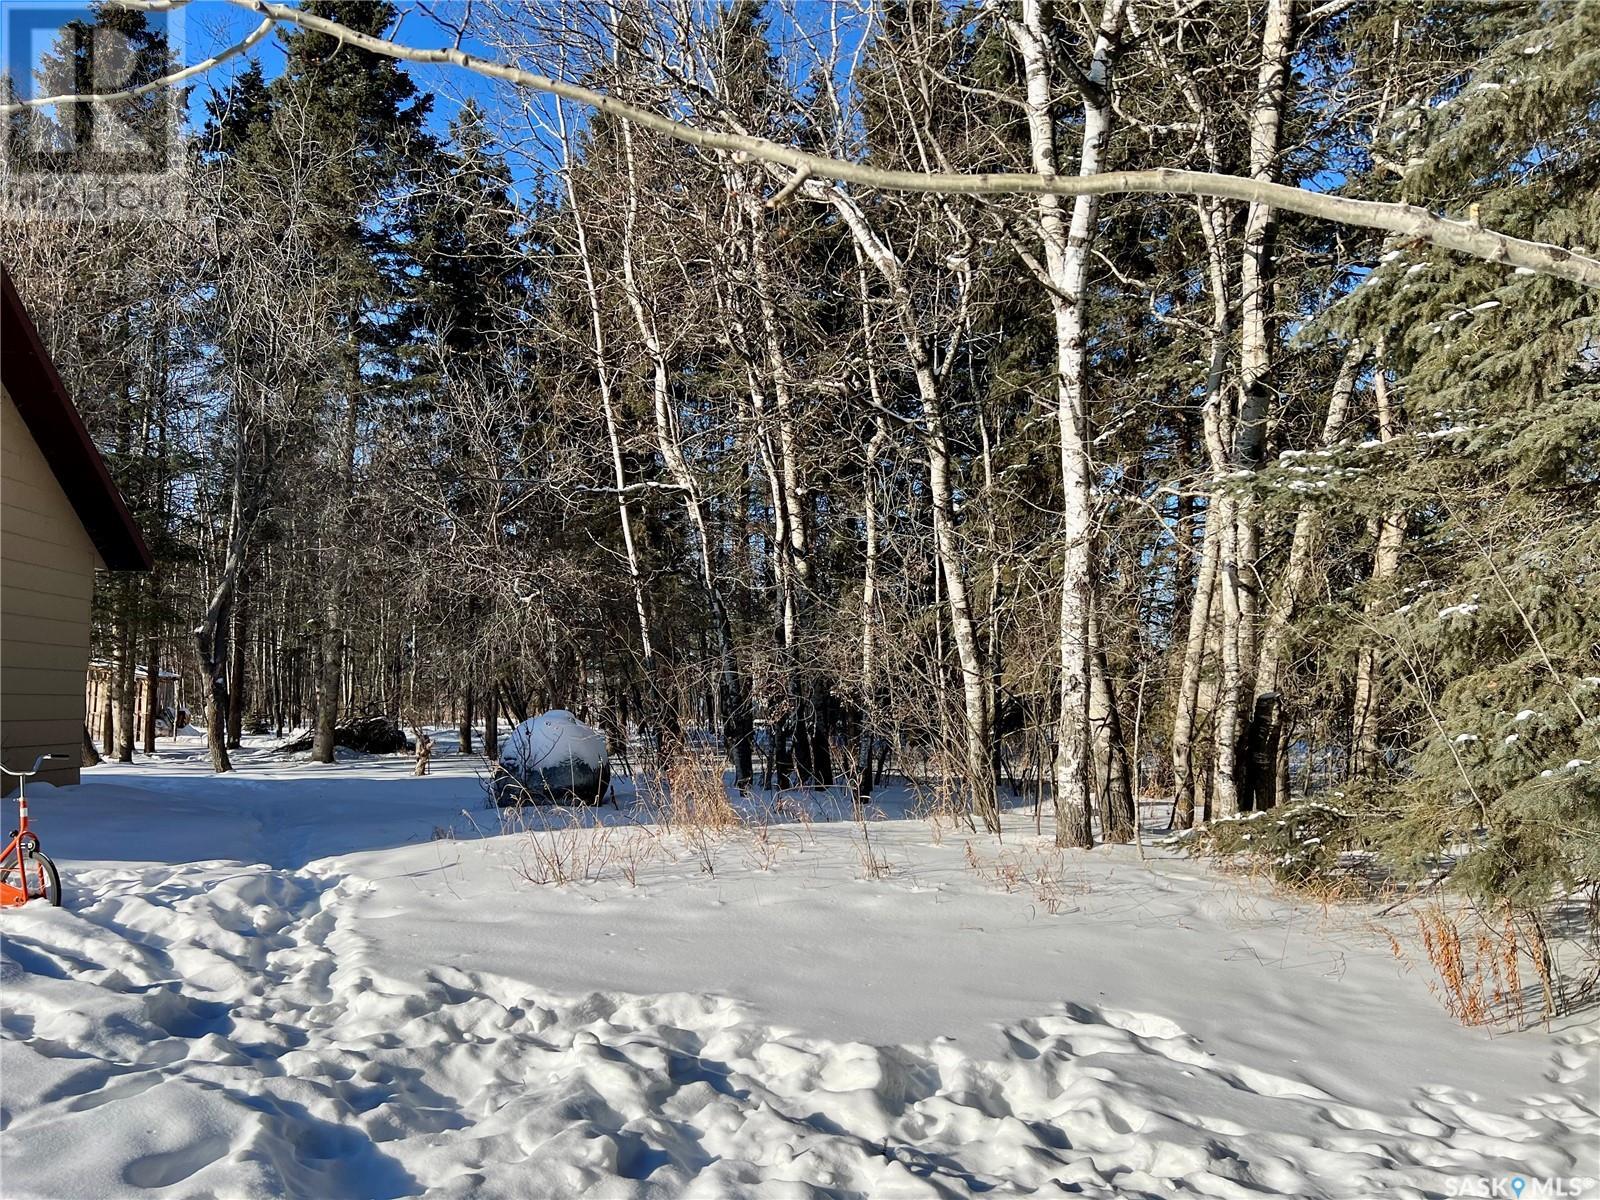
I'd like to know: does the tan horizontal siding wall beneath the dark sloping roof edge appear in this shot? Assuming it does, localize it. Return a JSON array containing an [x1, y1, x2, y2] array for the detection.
[[0, 389, 99, 792]]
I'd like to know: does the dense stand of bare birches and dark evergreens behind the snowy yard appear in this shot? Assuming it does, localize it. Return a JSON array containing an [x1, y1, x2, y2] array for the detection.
[[0, 0, 1600, 912]]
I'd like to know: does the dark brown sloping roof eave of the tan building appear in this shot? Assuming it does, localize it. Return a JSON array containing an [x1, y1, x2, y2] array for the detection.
[[0, 266, 155, 571]]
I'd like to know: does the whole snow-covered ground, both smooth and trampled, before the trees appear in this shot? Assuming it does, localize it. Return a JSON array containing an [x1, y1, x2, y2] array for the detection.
[[0, 739, 1600, 1200]]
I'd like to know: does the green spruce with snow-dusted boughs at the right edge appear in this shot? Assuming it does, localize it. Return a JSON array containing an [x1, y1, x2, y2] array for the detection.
[[1209, 5, 1600, 944]]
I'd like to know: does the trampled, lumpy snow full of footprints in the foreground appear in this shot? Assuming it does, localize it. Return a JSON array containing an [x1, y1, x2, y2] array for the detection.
[[0, 862, 1600, 1200]]
